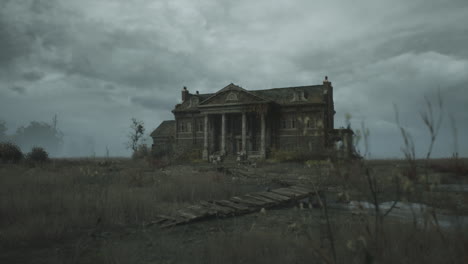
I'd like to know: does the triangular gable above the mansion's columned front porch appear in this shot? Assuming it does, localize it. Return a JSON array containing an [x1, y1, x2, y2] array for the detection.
[[199, 83, 269, 106]]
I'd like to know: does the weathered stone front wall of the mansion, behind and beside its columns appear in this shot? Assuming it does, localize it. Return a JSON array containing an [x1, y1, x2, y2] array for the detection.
[[175, 98, 333, 159]]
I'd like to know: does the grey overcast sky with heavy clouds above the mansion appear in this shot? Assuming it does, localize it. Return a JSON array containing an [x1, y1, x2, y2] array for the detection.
[[0, 0, 468, 158]]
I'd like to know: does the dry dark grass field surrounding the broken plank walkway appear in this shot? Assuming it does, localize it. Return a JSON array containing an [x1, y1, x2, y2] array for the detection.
[[0, 159, 468, 263]]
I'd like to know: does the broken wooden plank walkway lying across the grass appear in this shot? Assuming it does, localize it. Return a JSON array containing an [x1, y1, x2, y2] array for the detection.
[[152, 186, 315, 228]]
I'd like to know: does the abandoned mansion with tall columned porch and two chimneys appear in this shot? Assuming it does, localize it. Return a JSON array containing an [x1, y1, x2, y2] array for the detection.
[[151, 77, 353, 160]]
